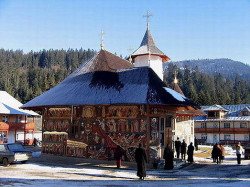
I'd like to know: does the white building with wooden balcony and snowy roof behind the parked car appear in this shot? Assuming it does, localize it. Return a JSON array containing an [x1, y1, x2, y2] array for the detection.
[[0, 91, 39, 145]]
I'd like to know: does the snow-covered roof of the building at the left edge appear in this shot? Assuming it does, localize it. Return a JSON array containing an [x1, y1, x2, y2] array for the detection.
[[0, 91, 39, 116]]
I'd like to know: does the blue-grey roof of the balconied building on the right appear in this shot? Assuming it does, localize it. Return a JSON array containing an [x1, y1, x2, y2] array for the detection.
[[195, 104, 250, 121]]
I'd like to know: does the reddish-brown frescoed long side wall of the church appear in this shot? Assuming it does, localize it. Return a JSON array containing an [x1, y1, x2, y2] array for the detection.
[[43, 105, 148, 161]]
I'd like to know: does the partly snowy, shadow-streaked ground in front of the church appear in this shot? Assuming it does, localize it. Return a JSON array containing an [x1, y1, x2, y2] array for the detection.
[[0, 147, 250, 187]]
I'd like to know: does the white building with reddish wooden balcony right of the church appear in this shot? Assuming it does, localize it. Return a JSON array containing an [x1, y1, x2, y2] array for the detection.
[[195, 104, 250, 144]]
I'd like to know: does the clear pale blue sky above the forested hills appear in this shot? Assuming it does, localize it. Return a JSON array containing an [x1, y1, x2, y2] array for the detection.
[[0, 0, 250, 64]]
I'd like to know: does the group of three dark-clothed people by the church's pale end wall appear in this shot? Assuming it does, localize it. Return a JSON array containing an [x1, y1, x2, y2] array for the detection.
[[174, 137, 194, 163]]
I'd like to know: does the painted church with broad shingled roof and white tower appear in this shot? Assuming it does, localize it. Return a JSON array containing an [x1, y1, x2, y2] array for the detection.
[[22, 23, 199, 161]]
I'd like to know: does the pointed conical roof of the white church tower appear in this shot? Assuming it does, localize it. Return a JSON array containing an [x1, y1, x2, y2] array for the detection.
[[131, 27, 170, 62]]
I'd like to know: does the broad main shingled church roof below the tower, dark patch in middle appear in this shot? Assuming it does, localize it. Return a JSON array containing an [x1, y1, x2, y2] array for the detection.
[[22, 50, 198, 110]]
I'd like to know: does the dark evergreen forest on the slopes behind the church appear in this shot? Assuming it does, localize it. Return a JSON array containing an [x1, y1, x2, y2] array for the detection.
[[0, 49, 250, 105]]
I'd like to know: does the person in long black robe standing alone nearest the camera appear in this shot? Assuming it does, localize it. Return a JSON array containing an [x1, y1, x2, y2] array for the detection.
[[135, 143, 147, 180]]
